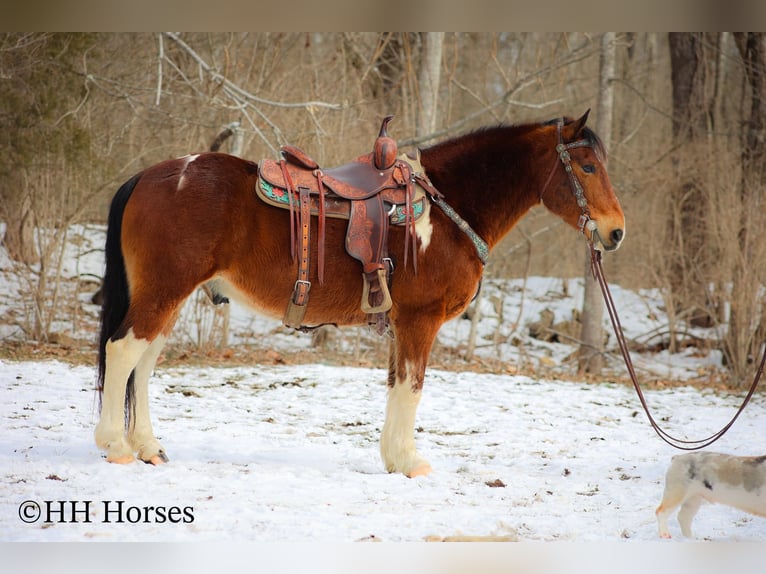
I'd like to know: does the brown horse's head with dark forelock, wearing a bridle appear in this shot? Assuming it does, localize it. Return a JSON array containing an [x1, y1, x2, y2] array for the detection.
[[540, 110, 625, 251]]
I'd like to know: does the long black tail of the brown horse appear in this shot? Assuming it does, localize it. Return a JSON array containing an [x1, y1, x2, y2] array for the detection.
[[98, 174, 141, 412]]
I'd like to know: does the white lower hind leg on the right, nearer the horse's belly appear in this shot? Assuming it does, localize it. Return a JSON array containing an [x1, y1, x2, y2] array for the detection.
[[128, 335, 167, 463]]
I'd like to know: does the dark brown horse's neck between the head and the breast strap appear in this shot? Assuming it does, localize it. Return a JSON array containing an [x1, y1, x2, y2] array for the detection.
[[421, 136, 547, 251]]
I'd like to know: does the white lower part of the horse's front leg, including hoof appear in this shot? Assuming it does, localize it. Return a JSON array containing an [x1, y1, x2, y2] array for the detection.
[[380, 364, 431, 476]]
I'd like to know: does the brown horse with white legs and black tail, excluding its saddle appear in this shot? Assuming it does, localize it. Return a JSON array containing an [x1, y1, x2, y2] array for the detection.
[[95, 112, 625, 476]]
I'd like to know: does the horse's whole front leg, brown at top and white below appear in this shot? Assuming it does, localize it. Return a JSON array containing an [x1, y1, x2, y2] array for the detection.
[[380, 321, 439, 477]]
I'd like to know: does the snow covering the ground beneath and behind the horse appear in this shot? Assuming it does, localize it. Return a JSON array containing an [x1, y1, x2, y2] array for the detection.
[[0, 228, 766, 552]]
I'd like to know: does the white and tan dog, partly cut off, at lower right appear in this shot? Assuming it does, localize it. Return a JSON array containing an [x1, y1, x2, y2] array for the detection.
[[655, 452, 766, 538]]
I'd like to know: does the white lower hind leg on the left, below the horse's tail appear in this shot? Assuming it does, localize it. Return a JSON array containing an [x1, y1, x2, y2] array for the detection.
[[95, 329, 149, 462]]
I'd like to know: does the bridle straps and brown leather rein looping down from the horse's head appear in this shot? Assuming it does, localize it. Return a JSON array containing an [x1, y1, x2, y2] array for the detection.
[[540, 120, 766, 451]]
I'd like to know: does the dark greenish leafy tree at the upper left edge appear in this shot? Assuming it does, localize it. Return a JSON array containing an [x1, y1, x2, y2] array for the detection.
[[0, 33, 92, 265]]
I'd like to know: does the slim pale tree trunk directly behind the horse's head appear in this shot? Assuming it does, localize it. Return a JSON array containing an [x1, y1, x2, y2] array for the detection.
[[577, 32, 617, 374]]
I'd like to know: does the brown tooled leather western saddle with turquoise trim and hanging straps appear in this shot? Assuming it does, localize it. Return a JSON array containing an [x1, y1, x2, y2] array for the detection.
[[257, 116, 440, 334]]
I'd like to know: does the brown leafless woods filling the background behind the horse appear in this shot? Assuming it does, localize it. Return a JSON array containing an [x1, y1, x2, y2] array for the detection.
[[0, 32, 766, 390]]
